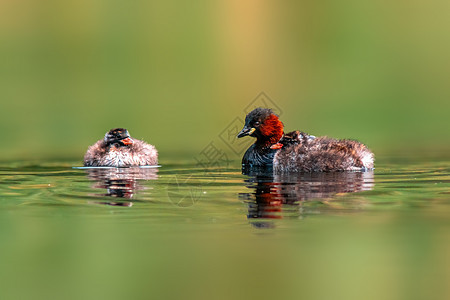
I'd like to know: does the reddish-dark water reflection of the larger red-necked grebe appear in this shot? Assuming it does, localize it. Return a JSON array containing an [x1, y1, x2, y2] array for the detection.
[[240, 171, 374, 227]]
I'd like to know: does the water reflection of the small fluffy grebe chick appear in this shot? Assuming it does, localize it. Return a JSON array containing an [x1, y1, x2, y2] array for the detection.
[[86, 167, 158, 206]]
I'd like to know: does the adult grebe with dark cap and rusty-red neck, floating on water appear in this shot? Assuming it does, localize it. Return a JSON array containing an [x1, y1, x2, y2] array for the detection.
[[238, 108, 374, 173]]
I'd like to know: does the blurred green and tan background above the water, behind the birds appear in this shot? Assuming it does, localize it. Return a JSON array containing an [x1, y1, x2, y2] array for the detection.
[[0, 0, 450, 159]]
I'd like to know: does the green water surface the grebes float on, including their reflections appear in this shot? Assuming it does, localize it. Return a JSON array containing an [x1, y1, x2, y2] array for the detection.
[[0, 158, 450, 299]]
